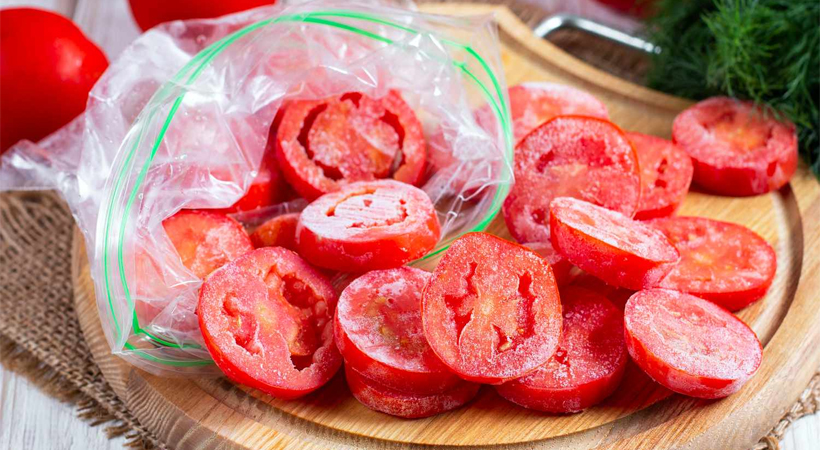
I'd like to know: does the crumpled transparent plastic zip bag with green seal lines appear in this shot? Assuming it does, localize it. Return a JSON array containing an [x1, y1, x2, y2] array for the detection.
[[0, 1, 512, 375]]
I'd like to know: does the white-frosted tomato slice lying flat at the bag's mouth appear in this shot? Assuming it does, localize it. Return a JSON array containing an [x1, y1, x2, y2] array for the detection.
[[296, 180, 441, 272]]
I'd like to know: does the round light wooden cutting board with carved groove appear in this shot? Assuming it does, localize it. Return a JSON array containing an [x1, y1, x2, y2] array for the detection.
[[73, 3, 820, 449]]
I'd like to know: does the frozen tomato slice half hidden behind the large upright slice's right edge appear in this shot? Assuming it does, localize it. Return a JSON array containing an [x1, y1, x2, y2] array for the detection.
[[626, 133, 692, 220]]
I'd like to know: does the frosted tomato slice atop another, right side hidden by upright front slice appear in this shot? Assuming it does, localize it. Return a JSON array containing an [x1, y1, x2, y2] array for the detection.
[[334, 267, 461, 395]]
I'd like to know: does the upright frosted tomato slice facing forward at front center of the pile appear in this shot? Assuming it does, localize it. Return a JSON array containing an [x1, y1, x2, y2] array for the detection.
[[422, 233, 561, 384]]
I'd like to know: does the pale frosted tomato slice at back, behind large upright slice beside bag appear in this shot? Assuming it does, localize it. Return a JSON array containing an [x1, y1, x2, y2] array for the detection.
[[476, 82, 609, 142]]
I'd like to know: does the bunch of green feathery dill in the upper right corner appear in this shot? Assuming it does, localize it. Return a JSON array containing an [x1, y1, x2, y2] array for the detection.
[[648, 0, 820, 177]]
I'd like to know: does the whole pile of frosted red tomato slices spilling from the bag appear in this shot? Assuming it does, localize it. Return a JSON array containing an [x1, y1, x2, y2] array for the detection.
[[137, 83, 797, 419]]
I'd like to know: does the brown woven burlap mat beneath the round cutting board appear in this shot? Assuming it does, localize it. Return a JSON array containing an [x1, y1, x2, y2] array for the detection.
[[0, 0, 820, 450]]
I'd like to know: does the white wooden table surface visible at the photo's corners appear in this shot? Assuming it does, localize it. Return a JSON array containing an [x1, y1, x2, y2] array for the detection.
[[0, 0, 820, 450]]
